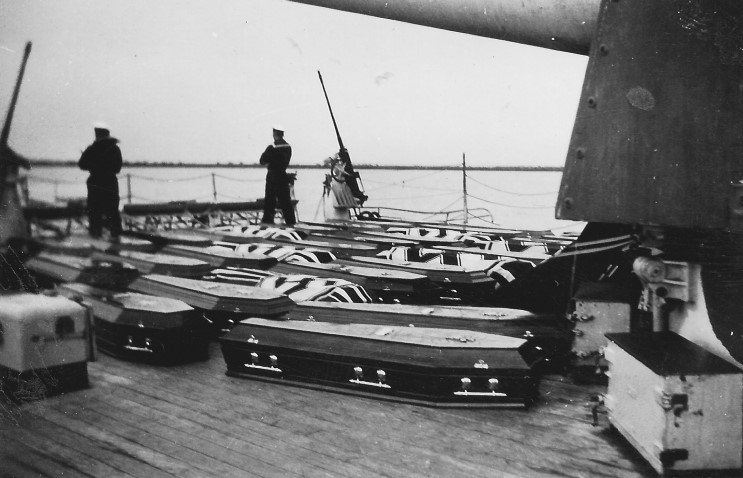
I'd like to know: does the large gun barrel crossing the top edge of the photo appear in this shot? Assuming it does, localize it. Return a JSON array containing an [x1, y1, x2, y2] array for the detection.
[[292, 0, 600, 55]]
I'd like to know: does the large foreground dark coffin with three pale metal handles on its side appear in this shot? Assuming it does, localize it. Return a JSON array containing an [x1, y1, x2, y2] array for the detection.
[[220, 318, 540, 407]]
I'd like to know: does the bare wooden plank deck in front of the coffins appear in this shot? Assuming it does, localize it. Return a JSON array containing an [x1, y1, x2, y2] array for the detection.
[[0, 342, 655, 478]]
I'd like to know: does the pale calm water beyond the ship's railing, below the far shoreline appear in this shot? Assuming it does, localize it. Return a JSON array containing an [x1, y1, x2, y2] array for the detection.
[[27, 166, 578, 230]]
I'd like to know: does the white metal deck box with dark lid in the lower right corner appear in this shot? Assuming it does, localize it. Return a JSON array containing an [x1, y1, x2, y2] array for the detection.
[[605, 332, 743, 476]]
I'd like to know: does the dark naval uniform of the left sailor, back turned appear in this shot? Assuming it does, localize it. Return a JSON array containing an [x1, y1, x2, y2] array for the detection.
[[78, 136, 122, 238]]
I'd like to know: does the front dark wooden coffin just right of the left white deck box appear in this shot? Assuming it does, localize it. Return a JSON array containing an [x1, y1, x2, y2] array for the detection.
[[57, 283, 209, 363]]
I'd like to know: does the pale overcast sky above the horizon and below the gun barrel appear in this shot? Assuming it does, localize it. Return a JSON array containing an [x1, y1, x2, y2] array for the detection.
[[0, 0, 587, 166]]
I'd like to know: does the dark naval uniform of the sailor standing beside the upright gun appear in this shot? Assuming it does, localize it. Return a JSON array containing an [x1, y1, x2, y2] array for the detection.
[[260, 138, 297, 226]]
